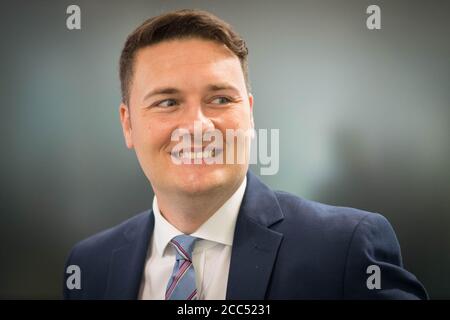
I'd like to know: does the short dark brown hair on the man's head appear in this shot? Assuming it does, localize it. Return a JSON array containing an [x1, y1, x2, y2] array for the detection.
[[120, 9, 250, 105]]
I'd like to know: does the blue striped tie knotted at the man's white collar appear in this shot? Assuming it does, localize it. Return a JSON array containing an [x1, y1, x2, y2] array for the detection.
[[166, 234, 197, 300]]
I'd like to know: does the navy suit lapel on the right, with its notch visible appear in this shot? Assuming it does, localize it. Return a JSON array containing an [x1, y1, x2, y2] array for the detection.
[[226, 171, 283, 300]]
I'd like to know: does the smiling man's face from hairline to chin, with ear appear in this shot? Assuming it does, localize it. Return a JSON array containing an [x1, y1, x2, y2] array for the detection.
[[120, 39, 253, 195]]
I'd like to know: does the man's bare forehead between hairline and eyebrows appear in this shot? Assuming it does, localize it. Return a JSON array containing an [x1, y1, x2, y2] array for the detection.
[[133, 39, 245, 90]]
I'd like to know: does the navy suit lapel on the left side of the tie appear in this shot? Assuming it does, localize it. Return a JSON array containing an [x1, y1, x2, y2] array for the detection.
[[105, 211, 154, 299]]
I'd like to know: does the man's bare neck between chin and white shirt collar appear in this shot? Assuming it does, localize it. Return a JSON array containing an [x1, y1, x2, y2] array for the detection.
[[155, 178, 244, 234]]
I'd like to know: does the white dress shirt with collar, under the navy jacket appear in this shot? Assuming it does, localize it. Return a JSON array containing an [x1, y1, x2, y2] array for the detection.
[[139, 177, 247, 300]]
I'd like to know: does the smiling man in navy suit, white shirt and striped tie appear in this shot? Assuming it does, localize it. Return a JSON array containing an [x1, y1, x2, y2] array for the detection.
[[64, 10, 427, 299]]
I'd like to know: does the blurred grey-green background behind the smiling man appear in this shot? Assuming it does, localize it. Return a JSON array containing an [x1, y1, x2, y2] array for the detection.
[[0, 0, 450, 299]]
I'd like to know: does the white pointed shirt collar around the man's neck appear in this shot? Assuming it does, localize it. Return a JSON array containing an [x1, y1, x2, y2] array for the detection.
[[153, 176, 247, 256]]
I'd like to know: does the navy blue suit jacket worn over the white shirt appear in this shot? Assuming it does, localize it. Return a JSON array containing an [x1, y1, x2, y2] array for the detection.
[[64, 171, 427, 299]]
